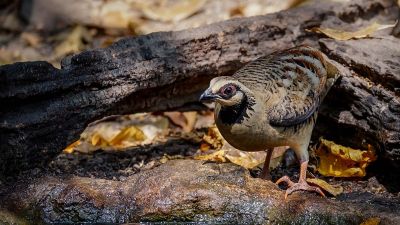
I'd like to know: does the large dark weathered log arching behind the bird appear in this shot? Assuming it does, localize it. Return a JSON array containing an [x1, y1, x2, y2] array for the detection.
[[0, 0, 400, 179]]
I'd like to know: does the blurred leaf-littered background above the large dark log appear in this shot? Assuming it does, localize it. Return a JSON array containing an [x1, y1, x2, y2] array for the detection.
[[0, 0, 332, 67]]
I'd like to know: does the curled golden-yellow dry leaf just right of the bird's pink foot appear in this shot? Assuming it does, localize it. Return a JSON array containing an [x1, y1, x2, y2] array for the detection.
[[315, 139, 376, 177]]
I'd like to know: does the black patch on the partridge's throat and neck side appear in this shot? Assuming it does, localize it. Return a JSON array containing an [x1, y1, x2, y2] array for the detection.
[[218, 95, 255, 125]]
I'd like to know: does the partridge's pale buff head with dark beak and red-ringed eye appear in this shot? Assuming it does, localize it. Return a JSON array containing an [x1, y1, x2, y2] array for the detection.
[[200, 76, 247, 106]]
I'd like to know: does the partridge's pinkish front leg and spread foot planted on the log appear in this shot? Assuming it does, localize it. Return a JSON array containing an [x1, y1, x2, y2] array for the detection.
[[276, 161, 325, 199]]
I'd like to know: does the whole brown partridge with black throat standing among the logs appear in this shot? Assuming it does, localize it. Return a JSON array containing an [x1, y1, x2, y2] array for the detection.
[[200, 45, 341, 198]]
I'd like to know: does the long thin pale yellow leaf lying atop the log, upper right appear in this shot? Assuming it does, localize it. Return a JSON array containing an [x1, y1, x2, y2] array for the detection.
[[306, 22, 397, 41]]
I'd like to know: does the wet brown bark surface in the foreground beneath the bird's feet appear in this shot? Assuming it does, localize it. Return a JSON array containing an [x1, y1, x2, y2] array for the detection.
[[0, 160, 400, 225]]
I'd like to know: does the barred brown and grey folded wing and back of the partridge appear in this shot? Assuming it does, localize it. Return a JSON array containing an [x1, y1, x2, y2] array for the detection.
[[234, 46, 327, 127]]
